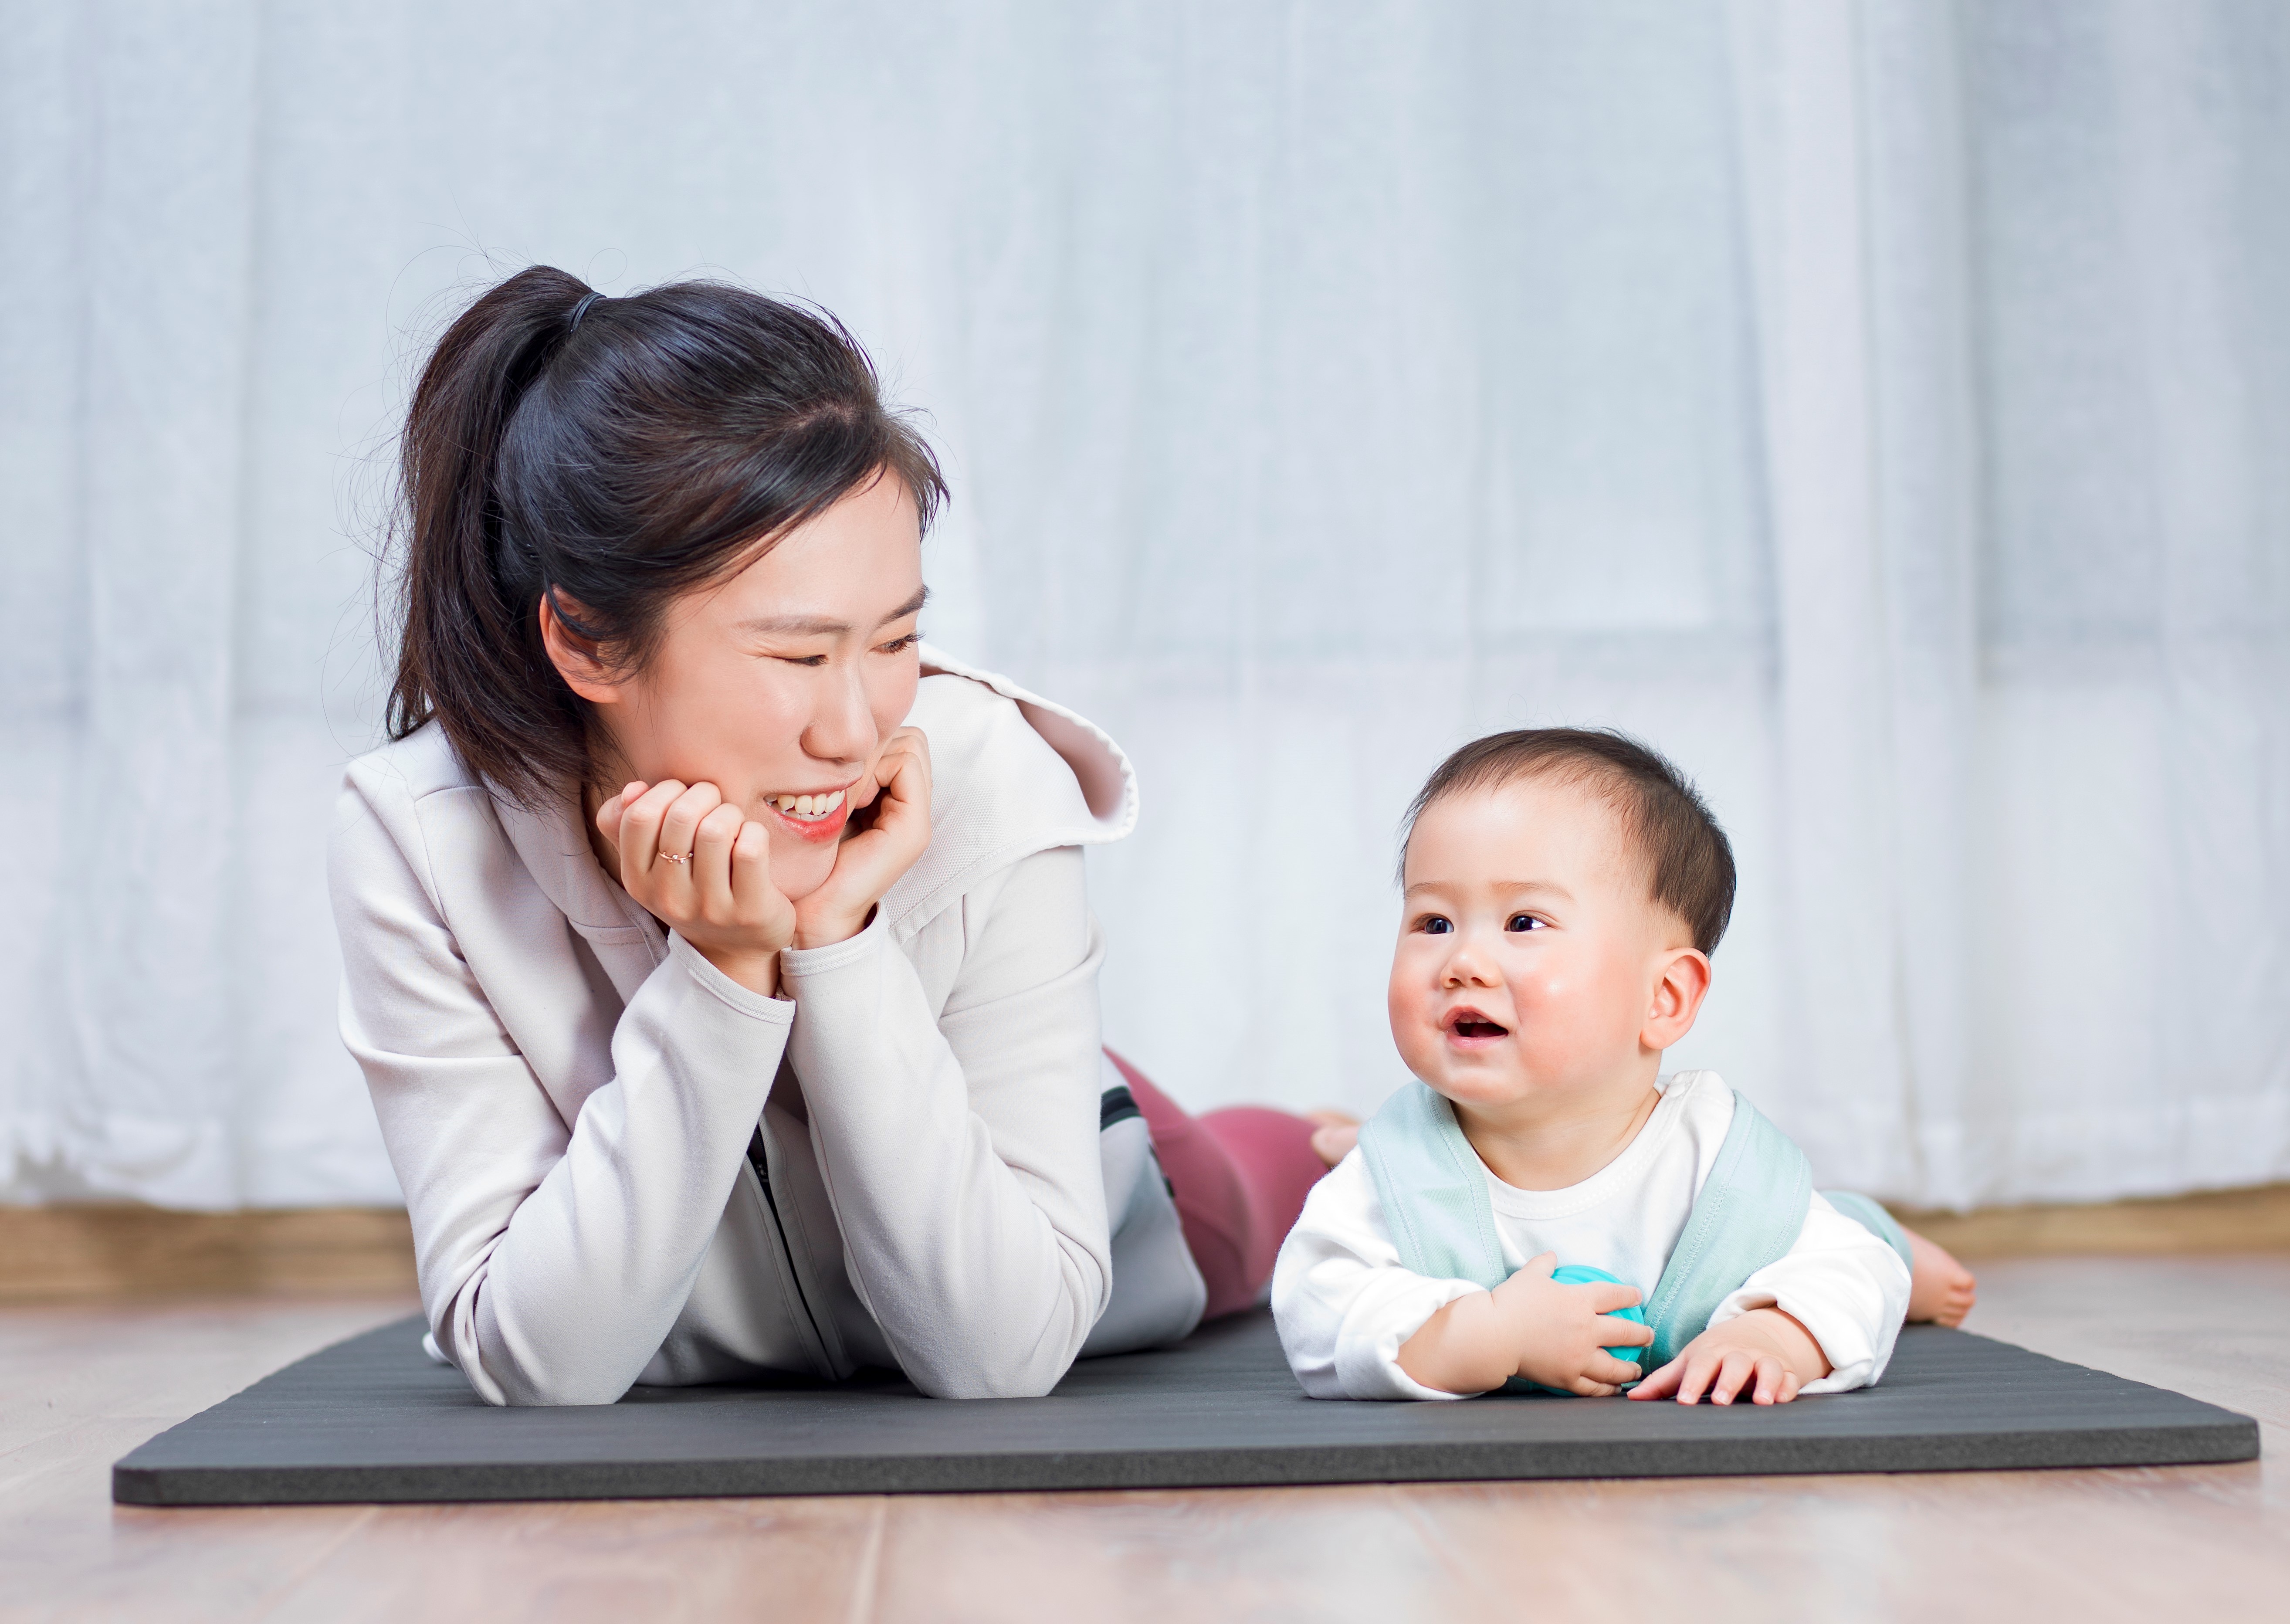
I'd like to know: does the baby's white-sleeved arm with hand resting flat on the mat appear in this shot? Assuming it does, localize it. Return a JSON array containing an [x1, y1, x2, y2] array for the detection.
[[1630, 1196, 1907, 1404]]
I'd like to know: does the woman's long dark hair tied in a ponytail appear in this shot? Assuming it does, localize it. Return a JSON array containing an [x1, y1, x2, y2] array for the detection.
[[390, 266, 946, 806]]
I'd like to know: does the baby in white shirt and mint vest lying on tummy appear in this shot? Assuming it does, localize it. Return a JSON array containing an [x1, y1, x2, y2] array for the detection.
[[1273, 729, 1972, 1404]]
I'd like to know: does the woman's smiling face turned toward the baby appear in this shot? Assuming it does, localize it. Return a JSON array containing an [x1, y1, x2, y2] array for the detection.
[[568, 474, 925, 900]]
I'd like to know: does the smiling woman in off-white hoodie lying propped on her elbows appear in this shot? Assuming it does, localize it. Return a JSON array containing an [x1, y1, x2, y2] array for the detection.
[[332, 268, 1324, 1404]]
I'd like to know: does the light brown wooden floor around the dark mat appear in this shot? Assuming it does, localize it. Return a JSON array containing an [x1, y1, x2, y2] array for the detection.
[[0, 1258, 2290, 1624]]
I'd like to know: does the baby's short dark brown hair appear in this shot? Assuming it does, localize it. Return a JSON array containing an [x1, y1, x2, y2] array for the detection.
[[1399, 729, 1734, 953]]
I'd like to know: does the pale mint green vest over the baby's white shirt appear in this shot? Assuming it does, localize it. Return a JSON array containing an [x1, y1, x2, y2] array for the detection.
[[1360, 1081, 1910, 1374]]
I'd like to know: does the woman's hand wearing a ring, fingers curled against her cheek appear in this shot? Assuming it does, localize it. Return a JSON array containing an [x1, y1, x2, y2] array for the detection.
[[596, 779, 797, 997]]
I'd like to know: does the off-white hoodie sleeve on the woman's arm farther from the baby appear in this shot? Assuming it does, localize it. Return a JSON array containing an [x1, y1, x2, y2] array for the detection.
[[328, 767, 795, 1404]]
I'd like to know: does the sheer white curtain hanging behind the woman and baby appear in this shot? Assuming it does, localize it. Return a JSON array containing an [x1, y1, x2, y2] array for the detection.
[[0, 0, 2290, 1207]]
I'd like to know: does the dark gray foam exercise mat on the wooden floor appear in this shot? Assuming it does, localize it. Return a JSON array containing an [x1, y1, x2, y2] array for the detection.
[[112, 1310, 2258, 1505]]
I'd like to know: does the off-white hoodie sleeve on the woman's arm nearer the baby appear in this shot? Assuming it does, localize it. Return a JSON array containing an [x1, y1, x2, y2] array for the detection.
[[783, 850, 1111, 1397]]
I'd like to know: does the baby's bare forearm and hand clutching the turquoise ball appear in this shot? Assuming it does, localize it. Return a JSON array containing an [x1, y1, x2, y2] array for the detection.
[[1399, 1253, 1653, 1397]]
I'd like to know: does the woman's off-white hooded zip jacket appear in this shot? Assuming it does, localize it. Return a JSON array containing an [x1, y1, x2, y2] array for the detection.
[[330, 648, 1202, 1404]]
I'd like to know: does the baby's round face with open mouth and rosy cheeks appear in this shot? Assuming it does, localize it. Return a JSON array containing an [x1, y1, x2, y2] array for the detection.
[[1390, 781, 1692, 1109]]
